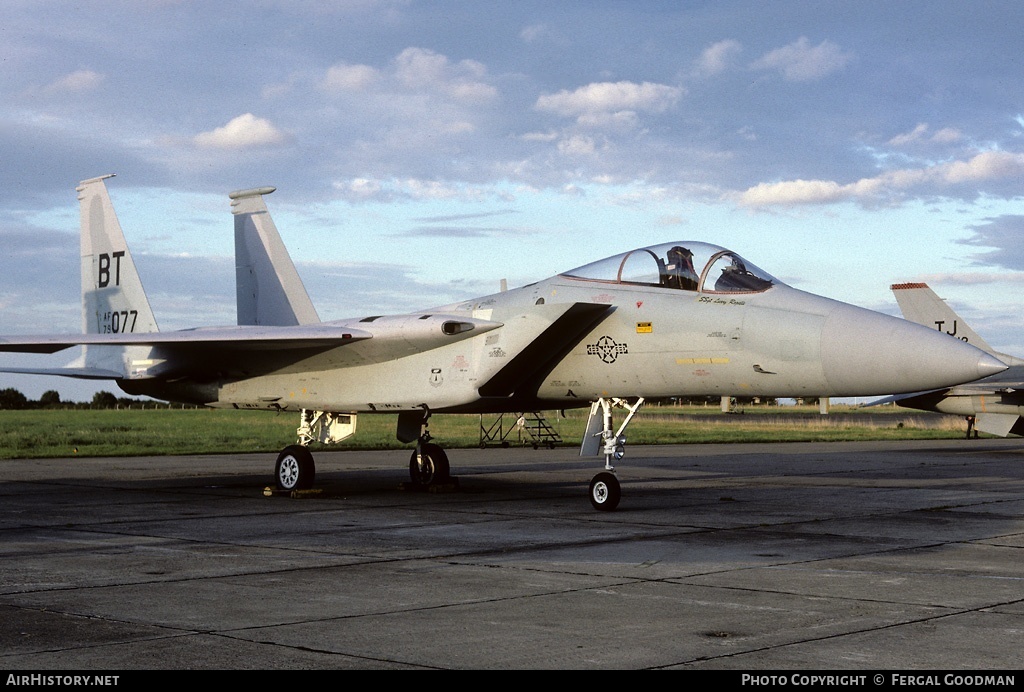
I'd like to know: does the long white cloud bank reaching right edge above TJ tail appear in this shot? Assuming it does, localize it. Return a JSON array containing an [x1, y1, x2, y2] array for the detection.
[[739, 152, 1024, 209]]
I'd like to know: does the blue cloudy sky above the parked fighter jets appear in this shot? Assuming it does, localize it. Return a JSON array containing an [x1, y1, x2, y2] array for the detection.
[[0, 0, 1024, 399]]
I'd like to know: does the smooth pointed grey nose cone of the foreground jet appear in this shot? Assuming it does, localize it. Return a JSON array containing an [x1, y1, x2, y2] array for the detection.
[[821, 304, 1007, 396]]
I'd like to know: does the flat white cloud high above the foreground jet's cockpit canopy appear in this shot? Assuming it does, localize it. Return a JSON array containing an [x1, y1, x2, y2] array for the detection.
[[534, 82, 683, 118]]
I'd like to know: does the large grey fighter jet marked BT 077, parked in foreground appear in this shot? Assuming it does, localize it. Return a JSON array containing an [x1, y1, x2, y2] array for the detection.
[[0, 176, 1006, 510]]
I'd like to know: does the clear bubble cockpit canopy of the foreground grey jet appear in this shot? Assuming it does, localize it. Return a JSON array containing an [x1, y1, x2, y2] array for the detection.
[[564, 241, 781, 293]]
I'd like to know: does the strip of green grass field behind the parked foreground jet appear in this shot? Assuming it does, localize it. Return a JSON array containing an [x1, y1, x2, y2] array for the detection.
[[0, 406, 966, 459]]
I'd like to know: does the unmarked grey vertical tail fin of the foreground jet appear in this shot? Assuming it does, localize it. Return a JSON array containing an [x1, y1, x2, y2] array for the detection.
[[228, 187, 319, 327]]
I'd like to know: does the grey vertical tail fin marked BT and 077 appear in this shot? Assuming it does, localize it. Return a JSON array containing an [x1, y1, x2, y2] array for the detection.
[[75, 175, 160, 375]]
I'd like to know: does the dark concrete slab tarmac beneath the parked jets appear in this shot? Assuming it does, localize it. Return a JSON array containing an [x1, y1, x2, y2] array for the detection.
[[0, 439, 1024, 671]]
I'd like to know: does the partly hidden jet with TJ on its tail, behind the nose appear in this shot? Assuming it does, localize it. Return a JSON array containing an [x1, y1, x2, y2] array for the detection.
[[890, 284, 1024, 437]]
